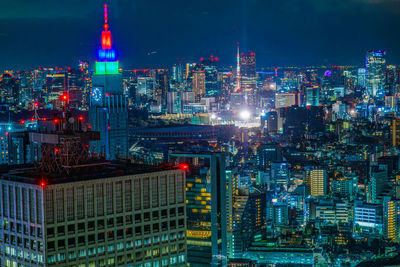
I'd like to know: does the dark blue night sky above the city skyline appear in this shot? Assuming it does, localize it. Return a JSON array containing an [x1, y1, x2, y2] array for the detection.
[[0, 0, 400, 69]]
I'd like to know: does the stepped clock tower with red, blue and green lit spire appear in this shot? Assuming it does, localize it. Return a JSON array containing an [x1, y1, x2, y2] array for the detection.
[[89, 5, 128, 160]]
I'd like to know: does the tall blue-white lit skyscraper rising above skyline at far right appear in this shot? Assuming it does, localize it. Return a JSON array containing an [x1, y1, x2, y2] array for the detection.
[[365, 50, 386, 96]]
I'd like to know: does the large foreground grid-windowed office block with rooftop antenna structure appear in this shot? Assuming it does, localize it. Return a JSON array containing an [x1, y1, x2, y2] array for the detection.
[[0, 105, 187, 266]]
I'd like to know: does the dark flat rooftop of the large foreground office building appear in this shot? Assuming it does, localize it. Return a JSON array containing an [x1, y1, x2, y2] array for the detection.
[[0, 160, 179, 186]]
